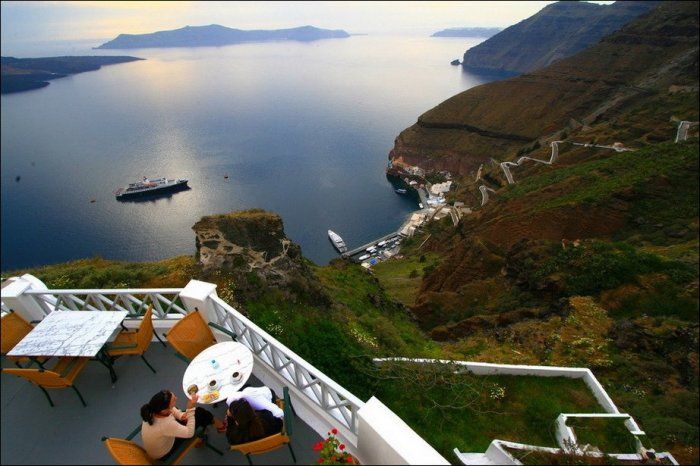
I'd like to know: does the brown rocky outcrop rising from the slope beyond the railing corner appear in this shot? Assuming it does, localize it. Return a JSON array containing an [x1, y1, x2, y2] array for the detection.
[[192, 209, 310, 284]]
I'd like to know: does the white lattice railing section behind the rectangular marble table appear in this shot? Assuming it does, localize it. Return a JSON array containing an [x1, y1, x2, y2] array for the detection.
[[24, 288, 187, 319]]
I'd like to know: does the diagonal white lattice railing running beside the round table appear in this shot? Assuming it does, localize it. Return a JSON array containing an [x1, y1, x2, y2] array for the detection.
[[210, 295, 365, 435]]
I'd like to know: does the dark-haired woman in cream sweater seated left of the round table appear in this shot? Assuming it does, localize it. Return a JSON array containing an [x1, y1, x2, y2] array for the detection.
[[141, 390, 223, 459]]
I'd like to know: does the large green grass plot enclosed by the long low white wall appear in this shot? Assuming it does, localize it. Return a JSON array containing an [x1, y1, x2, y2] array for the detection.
[[377, 365, 603, 458]]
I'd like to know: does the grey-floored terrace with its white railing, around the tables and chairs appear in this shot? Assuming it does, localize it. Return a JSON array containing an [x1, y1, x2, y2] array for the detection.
[[2, 275, 448, 464]]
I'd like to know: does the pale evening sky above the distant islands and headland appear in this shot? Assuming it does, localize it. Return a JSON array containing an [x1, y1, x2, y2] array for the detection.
[[0, 1, 611, 54]]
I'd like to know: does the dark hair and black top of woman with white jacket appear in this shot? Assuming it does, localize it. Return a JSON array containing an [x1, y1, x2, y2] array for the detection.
[[226, 398, 282, 445]]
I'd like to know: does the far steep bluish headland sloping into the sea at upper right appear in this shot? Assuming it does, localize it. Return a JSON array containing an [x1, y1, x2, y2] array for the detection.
[[463, 1, 659, 73]]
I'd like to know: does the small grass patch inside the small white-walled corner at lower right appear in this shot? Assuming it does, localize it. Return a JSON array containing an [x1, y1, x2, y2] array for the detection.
[[567, 418, 637, 453]]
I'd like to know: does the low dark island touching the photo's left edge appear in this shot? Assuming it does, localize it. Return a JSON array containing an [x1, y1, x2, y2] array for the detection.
[[0, 56, 143, 94]]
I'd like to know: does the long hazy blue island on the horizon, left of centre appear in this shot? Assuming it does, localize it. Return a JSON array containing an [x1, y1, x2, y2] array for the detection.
[[96, 24, 350, 49]]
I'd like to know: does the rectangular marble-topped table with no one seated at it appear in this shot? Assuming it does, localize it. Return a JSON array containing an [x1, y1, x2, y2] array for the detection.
[[7, 310, 128, 382]]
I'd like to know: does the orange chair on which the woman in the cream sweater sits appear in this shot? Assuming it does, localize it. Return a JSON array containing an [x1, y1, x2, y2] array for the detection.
[[102, 426, 223, 464]]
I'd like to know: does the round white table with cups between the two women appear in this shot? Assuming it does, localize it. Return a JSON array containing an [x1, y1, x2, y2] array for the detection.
[[182, 341, 253, 404]]
